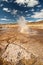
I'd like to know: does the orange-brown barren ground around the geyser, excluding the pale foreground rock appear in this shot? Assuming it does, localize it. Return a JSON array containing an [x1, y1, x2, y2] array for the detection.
[[0, 25, 43, 65]]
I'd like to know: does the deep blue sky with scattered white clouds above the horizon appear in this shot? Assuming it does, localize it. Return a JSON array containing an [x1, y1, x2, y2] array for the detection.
[[0, 0, 43, 23]]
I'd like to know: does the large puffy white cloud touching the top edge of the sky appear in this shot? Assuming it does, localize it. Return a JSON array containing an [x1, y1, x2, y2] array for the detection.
[[15, 0, 38, 7]]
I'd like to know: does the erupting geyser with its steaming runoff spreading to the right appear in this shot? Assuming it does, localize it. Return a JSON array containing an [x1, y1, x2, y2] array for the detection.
[[17, 16, 38, 35]]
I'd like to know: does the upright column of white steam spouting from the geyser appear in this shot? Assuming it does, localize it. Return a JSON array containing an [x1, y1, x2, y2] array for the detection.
[[18, 16, 29, 33]]
